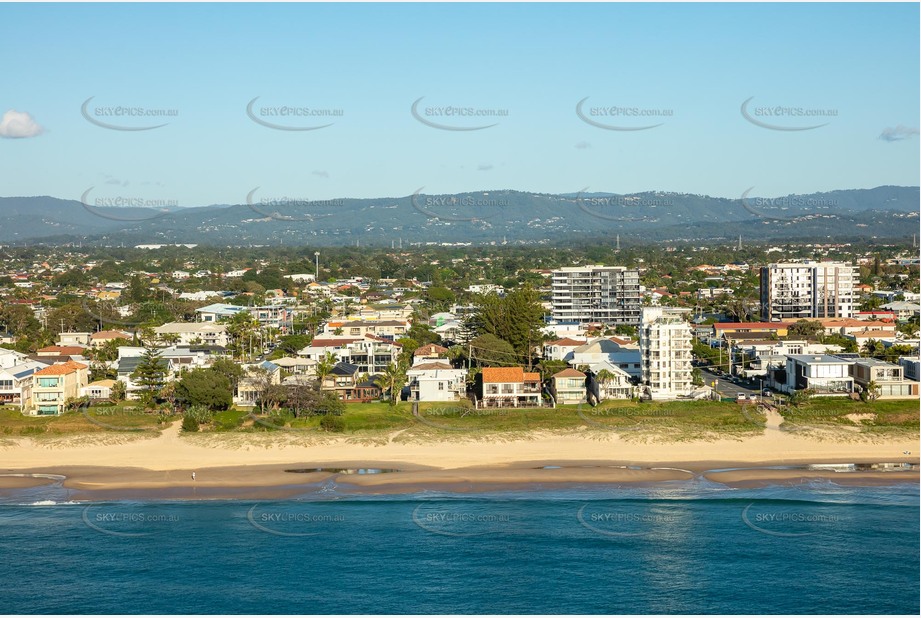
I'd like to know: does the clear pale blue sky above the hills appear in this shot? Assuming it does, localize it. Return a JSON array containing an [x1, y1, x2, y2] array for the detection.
[[0, 3, 921, 206]]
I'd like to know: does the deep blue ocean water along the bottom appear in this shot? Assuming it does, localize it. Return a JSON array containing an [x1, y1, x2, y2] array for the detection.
[[0, 481, 919, 615]]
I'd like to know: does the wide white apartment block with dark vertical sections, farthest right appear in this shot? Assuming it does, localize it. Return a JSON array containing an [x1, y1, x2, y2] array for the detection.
[[761, 260, 858, 322]]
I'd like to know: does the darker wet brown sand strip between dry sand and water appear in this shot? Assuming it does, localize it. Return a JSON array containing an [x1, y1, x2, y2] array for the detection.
[[0, 460, 921, 502]]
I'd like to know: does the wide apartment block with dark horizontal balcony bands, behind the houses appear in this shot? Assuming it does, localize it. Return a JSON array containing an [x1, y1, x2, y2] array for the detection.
[[551, 264, 642, 324]]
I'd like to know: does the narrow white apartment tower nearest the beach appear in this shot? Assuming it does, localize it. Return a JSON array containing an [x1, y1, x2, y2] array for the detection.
[[640, 307, 693, 399]]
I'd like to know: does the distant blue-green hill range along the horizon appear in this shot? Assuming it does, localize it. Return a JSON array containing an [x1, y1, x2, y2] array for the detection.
[[0, 186, 919, 246]]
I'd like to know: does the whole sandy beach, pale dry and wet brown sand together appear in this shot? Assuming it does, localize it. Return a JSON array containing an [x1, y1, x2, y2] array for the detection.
[[0, 424, 919, 499]]
